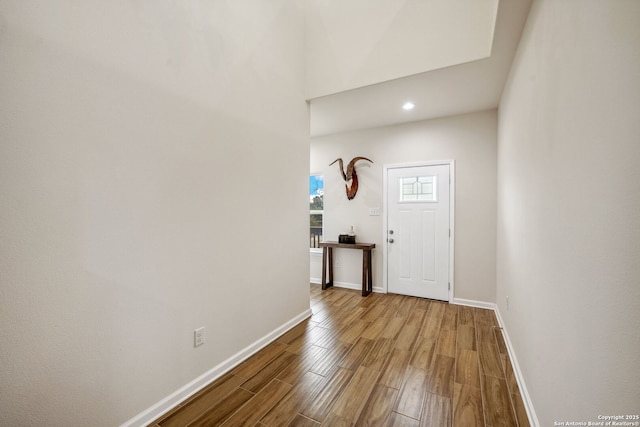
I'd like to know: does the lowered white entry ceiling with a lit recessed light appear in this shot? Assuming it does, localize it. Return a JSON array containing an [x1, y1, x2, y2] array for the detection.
[[309, 0, 532, 137]]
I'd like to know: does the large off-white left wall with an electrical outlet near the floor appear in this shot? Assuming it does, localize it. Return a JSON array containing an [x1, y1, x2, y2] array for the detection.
[[0, 0, 309, 426]]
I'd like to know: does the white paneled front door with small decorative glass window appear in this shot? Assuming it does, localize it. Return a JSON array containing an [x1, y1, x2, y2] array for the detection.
[[386, 164, 450, 301]]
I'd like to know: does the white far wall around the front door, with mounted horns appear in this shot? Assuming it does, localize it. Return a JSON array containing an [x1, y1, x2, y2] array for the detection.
[[311, 110, 497, 302]]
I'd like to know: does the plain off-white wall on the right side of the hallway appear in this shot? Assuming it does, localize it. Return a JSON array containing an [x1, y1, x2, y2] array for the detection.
[[498, 0, 640, 426]]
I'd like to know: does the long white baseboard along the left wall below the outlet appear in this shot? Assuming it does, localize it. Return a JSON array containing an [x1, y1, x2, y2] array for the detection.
[[120, 309, 311, 427]]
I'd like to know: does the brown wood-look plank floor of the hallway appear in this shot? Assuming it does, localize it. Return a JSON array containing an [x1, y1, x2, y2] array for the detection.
[[152, 285, 529, 427]]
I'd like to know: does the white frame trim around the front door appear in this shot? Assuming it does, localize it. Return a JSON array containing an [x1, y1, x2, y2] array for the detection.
[[381, 160, 456, 302]]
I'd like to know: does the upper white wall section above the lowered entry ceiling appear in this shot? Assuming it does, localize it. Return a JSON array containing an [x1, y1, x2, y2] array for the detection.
[[305, 0, 498, 98]]
